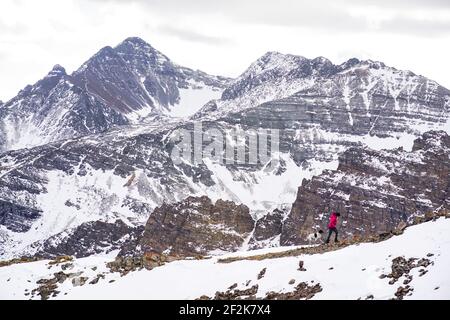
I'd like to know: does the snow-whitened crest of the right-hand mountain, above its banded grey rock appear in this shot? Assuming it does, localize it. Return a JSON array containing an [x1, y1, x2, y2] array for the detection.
[[194, 52, 450, 125]]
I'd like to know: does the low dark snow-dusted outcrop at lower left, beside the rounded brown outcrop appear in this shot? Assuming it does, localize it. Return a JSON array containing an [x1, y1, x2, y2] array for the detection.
[[34, 220, 144, 258]]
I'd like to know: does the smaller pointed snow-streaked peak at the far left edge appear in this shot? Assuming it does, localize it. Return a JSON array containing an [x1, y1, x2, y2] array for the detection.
[[0, 65, 129, 151]]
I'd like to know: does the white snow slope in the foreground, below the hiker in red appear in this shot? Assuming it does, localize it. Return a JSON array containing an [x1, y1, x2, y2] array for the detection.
[[0, 218, 450, 299]]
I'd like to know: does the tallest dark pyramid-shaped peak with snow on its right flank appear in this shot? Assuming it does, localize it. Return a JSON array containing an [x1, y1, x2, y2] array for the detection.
[[72, 38, 229, 120]]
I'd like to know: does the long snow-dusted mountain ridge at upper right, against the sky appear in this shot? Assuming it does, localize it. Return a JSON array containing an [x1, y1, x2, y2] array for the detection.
[[194, 52, 450, 127]]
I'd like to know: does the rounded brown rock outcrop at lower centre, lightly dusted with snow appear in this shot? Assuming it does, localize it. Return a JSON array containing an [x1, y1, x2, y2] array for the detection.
[[141, 197, 254, 256]]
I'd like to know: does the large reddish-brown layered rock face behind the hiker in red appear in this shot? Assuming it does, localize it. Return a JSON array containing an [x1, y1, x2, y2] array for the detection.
[[281, 131, 450, 245]]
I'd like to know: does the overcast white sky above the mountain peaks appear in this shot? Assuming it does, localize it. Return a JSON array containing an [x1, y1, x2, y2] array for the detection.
[[0, 0, 450, 101]]
